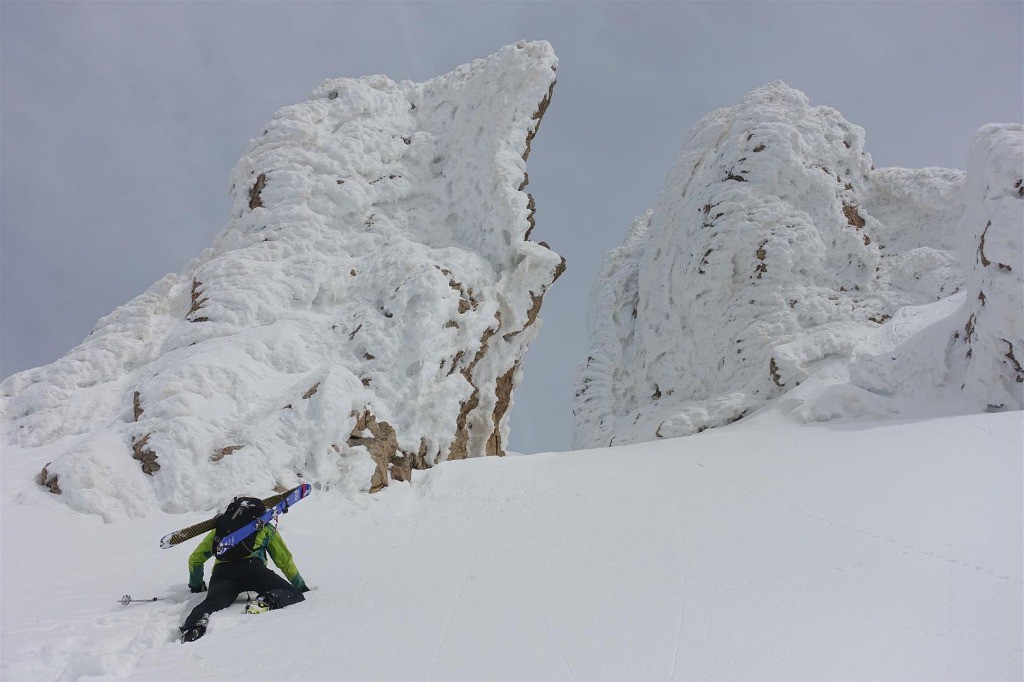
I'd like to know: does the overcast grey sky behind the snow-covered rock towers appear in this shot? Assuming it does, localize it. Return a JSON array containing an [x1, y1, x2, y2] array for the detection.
[[0, 1, 1024, 452]]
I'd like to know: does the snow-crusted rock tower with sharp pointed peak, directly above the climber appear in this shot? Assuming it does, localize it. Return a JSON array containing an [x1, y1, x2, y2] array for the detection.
[[0, 42, 564, 518]]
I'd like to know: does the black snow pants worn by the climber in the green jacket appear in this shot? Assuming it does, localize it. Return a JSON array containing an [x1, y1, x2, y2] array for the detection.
[[181, 557, 305, 630]]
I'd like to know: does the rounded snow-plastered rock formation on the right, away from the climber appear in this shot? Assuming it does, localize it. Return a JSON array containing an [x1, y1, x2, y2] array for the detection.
[[573, 82, 1024, 447]]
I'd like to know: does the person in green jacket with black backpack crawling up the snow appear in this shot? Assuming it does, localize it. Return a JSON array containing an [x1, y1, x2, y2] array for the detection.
[[179, 498, 309, 642]]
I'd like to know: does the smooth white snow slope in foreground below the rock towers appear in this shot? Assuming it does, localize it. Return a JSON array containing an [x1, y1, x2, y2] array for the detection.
[[0, 412, 1024, 682]]
